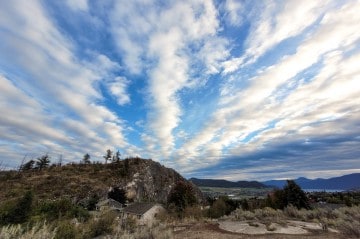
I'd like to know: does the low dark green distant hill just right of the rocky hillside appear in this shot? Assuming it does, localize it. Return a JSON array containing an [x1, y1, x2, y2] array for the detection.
[[189, 178, 268, 188]]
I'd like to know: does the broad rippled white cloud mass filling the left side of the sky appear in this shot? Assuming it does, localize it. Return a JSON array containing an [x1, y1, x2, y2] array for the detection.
[[0, 1, 129, 165]]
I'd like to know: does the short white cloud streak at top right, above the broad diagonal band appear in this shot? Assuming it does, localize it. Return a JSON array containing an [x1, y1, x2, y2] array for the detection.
[[223, 0, 331, 73]]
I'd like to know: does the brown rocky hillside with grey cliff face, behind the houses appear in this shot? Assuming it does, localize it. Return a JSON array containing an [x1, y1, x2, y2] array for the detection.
[[0, 158, 202, 203]]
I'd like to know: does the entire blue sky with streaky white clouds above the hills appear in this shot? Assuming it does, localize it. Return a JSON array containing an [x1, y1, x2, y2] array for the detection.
[[0, 0, 360, 181]]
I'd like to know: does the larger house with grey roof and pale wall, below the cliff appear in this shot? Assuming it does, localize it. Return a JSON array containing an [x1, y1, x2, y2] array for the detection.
[[122, 203, 166, 224]]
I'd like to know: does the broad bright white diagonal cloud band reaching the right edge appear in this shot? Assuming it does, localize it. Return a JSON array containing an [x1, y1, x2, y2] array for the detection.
[[178, 2, 360, 174]]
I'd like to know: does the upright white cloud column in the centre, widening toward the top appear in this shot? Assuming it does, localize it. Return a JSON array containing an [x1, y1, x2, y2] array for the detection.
[[112, 1, 228, 157]]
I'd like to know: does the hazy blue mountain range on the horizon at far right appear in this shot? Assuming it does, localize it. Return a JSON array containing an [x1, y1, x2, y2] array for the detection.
[[262, 173, 360, 190]]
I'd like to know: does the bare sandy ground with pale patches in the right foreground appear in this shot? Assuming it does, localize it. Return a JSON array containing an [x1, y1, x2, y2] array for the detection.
[[175, 221, 342, 239]]
